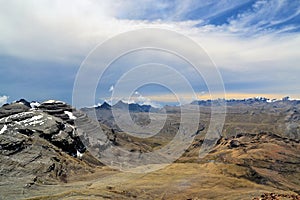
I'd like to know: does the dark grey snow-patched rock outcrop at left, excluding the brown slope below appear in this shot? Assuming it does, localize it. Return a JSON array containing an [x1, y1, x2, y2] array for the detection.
[[0, 100, 86, 157]]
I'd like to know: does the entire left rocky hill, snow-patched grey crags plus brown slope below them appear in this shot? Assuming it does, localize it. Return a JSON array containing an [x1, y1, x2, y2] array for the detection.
[[0, 100, 97, 190]]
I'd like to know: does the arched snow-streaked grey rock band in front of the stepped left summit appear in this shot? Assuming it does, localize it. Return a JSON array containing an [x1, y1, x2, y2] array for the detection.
[[0, 110, 85, 156]]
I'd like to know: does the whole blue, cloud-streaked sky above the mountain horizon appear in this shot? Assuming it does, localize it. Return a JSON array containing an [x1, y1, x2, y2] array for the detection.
[[0, 0, 300, 106]]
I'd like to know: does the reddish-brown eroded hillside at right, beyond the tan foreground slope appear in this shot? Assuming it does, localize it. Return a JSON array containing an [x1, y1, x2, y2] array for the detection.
[[177, 132, 300, 193]]
